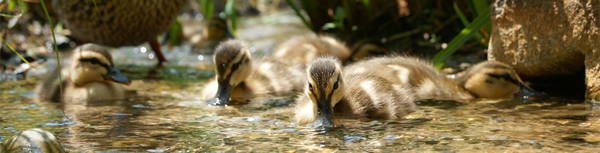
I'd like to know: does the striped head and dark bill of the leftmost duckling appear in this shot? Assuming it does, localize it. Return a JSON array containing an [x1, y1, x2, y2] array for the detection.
[[71, 44, 131, 86]]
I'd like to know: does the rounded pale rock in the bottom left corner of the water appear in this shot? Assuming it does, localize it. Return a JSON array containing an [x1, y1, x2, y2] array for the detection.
[[0, 129, 65, 153]]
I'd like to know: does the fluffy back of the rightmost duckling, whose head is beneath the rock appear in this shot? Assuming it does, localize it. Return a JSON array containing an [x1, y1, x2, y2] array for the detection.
[[347, 56, 473, 100]]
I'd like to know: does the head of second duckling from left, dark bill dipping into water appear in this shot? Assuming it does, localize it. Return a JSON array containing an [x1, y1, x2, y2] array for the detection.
[[214, 39, 252, 105]]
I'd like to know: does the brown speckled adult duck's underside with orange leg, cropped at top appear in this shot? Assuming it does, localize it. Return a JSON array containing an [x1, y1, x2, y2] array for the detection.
[[52, 0, 187, 66]]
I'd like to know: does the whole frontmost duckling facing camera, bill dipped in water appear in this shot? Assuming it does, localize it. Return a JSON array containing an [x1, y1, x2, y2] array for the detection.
[[295, 56, 417, 127]]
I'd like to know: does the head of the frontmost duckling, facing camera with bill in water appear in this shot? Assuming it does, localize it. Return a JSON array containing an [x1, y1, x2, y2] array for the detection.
[[304, 57, 345, 127]]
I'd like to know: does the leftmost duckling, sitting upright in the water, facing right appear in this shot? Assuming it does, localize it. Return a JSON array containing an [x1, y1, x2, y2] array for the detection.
[[35, 44, 131, 102]]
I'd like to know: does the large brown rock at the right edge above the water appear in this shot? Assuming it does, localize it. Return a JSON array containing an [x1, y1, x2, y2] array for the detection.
[[488, 0, 600, 100]]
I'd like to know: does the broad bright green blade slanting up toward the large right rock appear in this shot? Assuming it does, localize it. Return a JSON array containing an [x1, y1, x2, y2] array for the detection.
[[431, 7, 491, 69]]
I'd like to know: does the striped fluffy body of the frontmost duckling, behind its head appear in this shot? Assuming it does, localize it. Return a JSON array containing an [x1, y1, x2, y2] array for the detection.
[[333, 72, 417, 120]]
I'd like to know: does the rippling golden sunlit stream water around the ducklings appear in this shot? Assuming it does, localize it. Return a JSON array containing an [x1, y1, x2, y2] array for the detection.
[[0, 9, 600, 152]]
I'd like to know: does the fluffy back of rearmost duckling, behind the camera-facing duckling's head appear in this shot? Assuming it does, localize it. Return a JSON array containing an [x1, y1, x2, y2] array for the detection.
[[272, 34, 351, 64]]
